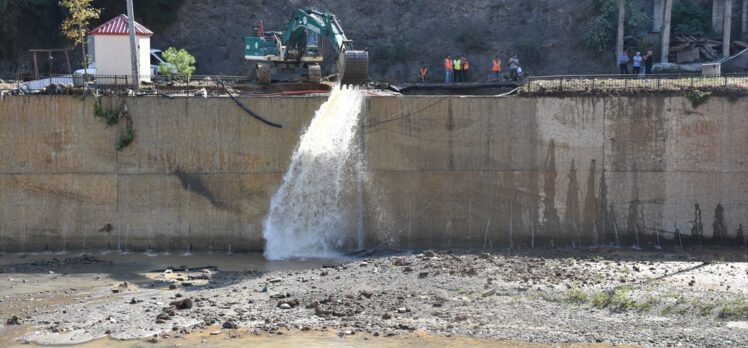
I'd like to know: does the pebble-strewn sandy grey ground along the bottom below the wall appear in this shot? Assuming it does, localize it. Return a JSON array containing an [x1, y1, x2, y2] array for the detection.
[[0, 250, 748, 347]]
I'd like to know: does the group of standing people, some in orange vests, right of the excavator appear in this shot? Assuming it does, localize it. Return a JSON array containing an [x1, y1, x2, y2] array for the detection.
[[419, 54, 523, 83]]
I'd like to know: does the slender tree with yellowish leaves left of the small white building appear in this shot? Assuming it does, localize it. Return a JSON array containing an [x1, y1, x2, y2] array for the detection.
[[59, 0, 101, 73]]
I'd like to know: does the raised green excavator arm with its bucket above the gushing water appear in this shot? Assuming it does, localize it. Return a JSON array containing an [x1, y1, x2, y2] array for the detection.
[[282, 9, 369, 85]]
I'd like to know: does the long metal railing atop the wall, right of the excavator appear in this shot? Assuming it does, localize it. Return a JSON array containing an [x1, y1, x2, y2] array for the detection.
[[524, 74, 748, 94]]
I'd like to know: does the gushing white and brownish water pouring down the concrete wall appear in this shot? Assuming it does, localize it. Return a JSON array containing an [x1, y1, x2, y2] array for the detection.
[[263, 86, 364, 260]]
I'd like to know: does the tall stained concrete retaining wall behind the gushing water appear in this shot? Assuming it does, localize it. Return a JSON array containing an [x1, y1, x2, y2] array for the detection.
[[0, 96, 748, 251]]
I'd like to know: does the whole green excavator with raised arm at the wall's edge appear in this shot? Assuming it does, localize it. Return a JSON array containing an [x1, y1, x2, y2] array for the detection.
[[244, 8, 369, 85]]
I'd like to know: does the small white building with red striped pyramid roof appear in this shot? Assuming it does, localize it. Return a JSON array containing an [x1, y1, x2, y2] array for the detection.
[[91, 14, 153, 83]]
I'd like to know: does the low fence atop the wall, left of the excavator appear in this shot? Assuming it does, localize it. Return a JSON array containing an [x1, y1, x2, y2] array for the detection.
[[0, 74, 248, 93]]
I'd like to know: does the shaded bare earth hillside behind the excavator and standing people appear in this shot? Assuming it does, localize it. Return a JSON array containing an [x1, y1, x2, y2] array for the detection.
[[0, 0, 672, 81]]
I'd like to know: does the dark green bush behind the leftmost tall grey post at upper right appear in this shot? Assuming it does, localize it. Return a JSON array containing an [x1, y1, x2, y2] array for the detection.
[[580, 0, 649, 53]]
